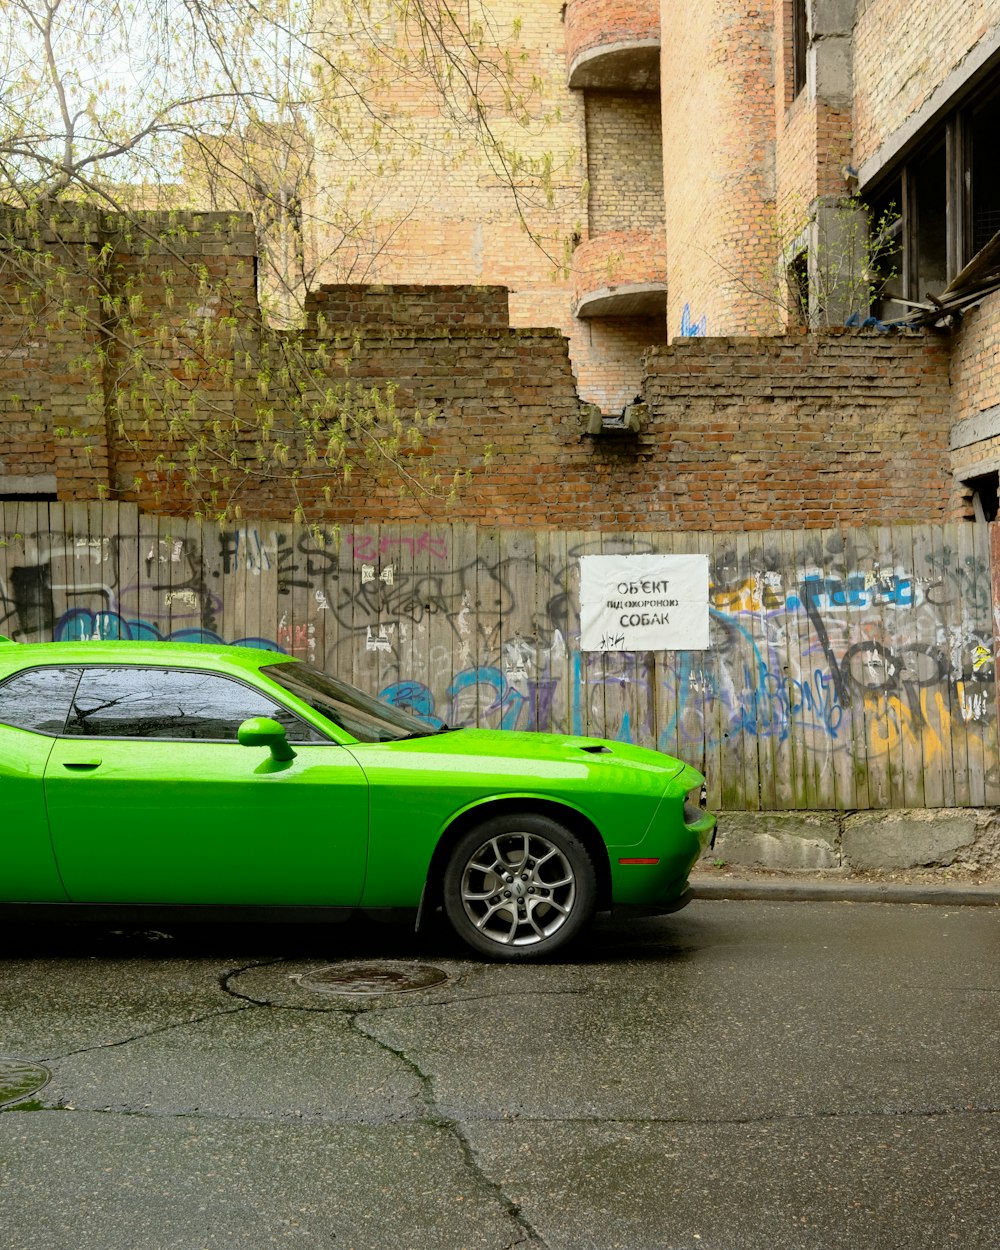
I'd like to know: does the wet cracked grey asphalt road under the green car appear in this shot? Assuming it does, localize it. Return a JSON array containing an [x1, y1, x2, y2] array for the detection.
[[0, 901, 1000, 1250]]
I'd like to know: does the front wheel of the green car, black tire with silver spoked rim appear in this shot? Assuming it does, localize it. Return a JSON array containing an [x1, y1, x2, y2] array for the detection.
[[443, 813, 598, 961]]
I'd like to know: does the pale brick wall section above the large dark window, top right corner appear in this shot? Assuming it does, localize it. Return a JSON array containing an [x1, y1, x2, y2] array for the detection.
[[854, 0, 1000, 168]]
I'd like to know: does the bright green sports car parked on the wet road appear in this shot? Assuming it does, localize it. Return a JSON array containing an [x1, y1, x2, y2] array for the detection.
[[0, 639, 715, 960]]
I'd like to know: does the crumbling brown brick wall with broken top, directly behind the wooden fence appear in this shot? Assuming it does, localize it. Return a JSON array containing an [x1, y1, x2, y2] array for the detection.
[[0, 214, 965, 531]]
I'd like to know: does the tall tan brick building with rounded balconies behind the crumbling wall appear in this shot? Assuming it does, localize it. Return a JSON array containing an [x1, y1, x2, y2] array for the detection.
[[302, 0, 1000, 517]]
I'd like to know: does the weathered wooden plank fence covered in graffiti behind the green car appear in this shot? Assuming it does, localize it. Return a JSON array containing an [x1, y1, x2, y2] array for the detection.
[[0, 504, 1000, 810]]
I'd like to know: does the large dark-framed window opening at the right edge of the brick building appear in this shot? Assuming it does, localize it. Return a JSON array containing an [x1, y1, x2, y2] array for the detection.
[[870, 78, 1000, 320]]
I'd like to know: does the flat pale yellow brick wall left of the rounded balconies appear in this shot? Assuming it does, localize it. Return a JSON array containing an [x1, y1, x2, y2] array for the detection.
[[306, 0, 585, 307]]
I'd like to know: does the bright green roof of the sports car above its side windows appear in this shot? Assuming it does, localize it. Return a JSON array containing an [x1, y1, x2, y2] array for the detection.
[[0, 639, 299, 671]]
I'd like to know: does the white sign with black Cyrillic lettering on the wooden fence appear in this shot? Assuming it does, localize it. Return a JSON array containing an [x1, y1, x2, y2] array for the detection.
[[580, 555, 709, 651]]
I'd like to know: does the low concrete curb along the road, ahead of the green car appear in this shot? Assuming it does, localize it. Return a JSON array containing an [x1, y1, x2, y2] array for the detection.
[[691, 878, 1000, 908]]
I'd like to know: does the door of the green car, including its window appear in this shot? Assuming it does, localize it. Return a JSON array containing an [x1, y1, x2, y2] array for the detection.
[[45, 665, 368, 906]]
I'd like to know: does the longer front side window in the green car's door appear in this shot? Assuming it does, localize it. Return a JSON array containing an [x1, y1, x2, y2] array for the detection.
[[66, 666, 326, 743]]
